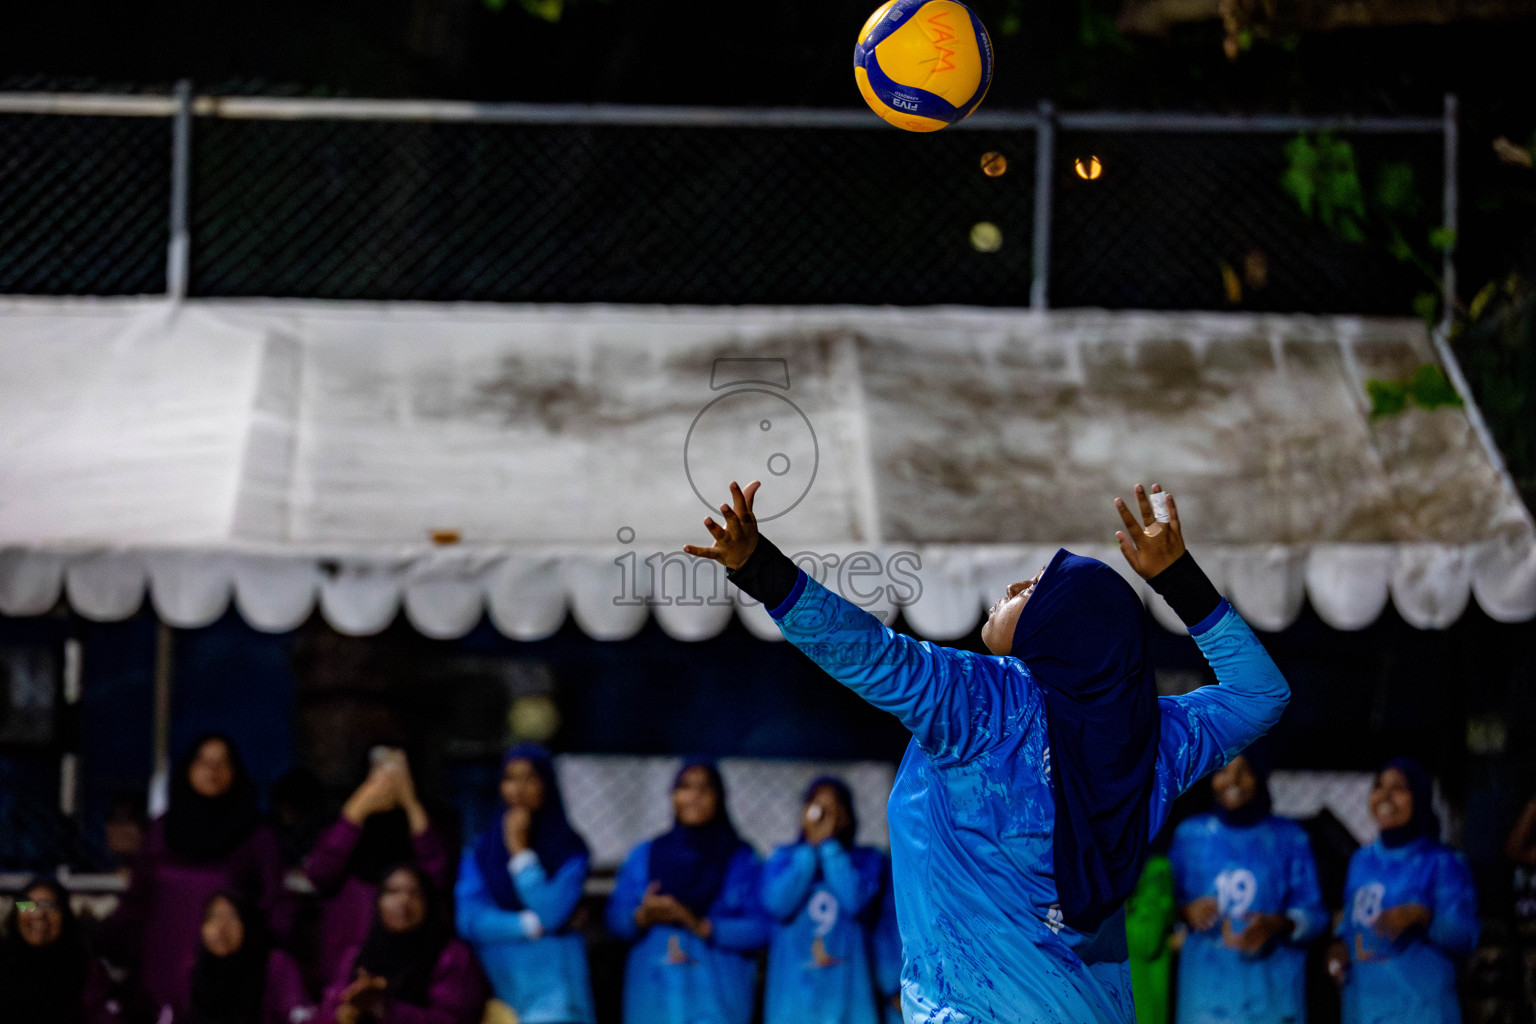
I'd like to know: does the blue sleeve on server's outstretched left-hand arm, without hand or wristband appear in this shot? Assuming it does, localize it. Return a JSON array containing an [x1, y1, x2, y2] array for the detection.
[[773, 571, 1040, 760]]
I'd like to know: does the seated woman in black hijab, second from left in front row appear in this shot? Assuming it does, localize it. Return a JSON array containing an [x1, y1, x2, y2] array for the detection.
[[180, 892, 315, 1024]]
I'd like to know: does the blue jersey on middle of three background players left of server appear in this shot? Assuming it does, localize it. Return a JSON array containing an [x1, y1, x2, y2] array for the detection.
[[608, 841, 768, 1024]]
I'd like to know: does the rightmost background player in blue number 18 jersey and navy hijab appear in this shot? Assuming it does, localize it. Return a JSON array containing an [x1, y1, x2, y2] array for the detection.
[[1329, 757, 1478, 1024]]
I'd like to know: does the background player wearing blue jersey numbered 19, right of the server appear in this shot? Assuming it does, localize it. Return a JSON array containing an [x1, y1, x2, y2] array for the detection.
[[1169, 748, 1329, 1024]]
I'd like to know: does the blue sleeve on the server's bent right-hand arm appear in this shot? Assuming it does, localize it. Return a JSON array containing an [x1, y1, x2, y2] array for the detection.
[[1154, 600, 1290, 798]]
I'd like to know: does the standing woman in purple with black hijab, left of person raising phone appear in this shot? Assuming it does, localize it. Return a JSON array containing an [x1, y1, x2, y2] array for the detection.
[[101, 735, 284, 1013]]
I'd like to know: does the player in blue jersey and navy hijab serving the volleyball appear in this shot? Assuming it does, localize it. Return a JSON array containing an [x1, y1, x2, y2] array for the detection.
[[685, 482, 1290, 1024]]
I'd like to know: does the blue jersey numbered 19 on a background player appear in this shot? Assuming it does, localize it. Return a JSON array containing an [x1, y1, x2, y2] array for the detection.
[[1169, 814, 1329, 1024]]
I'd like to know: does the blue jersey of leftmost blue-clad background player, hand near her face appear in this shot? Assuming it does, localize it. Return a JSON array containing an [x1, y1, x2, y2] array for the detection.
[[453, 849, 598, 1024]]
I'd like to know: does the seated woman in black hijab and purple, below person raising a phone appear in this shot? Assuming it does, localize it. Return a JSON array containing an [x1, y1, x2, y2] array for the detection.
[[319, 864, 485, 1024]]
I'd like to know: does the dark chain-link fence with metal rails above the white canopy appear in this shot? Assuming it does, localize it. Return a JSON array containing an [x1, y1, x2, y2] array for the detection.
[[0, 86, 1455, 313]]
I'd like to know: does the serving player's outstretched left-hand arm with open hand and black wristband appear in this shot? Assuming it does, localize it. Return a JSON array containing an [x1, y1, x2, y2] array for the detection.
[[684, 481, 1032, 758]]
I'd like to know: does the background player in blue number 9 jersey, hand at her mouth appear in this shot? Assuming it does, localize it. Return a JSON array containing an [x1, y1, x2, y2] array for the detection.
[[763, 775, 885, 1024]]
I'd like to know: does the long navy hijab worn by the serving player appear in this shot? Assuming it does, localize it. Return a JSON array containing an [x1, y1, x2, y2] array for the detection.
[[1012, 548, 1161, 932]]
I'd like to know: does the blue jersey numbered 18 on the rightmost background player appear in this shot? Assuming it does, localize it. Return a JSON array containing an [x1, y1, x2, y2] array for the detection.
[[1339, 838, 1478, 1024]]
